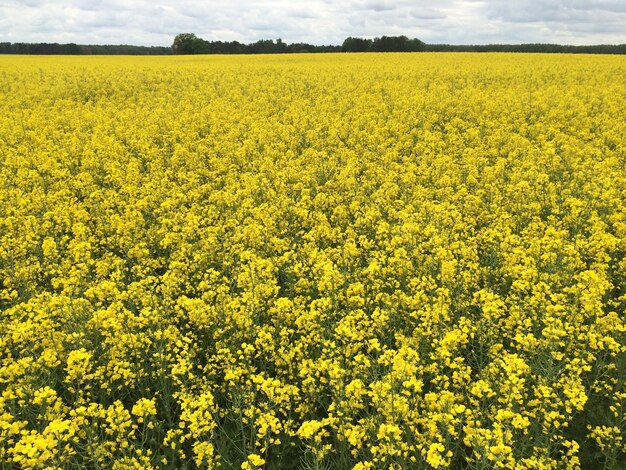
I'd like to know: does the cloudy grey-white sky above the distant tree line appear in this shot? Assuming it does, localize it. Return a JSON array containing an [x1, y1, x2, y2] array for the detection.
[[0, 0, 626, 46]]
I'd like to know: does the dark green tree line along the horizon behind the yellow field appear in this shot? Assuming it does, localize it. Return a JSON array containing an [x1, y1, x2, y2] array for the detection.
[[0, 33, 626, 55]]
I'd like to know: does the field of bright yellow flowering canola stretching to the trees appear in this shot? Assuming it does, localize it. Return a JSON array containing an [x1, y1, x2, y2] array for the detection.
[[0, 53, 626, 469]]
